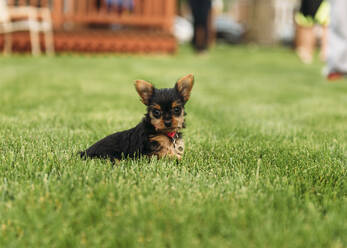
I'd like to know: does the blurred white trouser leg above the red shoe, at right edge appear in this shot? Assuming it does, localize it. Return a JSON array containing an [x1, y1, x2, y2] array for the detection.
[[326, 0, 347, 75]]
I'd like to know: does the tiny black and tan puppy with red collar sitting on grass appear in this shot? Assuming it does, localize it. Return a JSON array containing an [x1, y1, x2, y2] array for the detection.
[[80, 74, 194, 162]]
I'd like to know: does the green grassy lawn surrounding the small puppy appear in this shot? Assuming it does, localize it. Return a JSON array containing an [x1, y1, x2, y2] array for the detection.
[[0, 46, 347, 248]]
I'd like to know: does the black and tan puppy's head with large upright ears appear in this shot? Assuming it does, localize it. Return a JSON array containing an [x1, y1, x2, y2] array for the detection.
[[135, 74, 194, 133]]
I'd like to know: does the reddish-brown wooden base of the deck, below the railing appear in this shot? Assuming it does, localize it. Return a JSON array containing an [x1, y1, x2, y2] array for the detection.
[[0, 31, 177, 53]]
